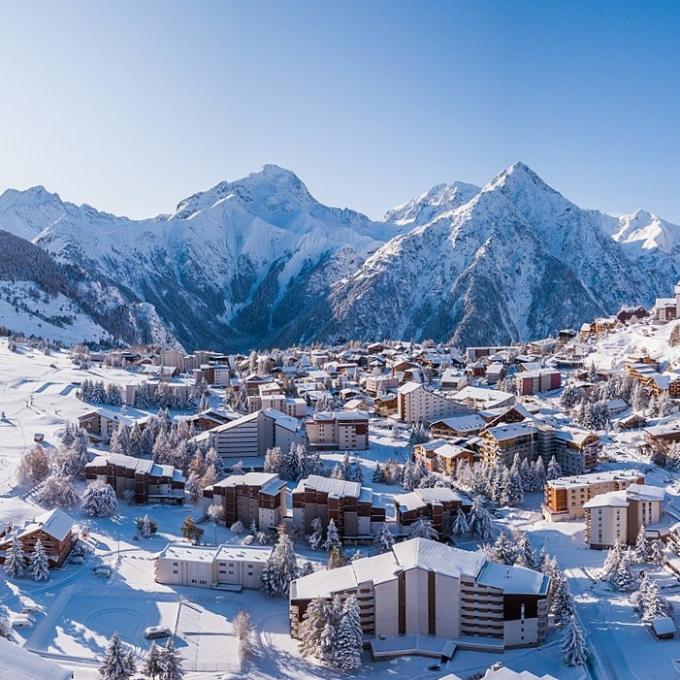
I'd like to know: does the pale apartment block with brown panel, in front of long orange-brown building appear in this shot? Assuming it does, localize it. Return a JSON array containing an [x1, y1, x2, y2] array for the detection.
[[583, 483, 666, 550]]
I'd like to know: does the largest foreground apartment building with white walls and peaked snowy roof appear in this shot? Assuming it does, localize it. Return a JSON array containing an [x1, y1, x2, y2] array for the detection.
[[290, 538, 550, 652]]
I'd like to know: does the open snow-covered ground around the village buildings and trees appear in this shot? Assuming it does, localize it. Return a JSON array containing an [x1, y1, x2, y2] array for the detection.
[[0, 331, 680, 680]]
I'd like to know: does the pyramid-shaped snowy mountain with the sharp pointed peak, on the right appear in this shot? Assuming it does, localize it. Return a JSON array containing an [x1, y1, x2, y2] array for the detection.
[[308, 163, 680, 345]]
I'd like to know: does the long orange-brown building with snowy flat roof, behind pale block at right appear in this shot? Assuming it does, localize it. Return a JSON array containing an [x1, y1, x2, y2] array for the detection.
[[542, 470, 645, 522]]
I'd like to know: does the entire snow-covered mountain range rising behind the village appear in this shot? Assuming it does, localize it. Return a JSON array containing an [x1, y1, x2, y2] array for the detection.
[[0, 163, 680, 350]]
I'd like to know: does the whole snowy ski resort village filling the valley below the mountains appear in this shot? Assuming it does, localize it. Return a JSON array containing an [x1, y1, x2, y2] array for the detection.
[[7, 286, 680, 680]]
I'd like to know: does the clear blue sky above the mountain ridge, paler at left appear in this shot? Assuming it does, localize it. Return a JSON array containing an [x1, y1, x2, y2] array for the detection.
[[0, 0, 680, 223]]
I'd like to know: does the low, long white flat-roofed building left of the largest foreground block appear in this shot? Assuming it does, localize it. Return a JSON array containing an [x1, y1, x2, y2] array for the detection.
[[154, 543, 272, 590]]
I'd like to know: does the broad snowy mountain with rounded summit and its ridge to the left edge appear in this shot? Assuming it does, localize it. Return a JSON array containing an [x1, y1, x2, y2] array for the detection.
[[0, 165, 397, 349]]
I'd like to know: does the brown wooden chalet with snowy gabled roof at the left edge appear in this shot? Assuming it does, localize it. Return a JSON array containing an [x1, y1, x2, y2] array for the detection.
[[0, 508, 76, 568]]
